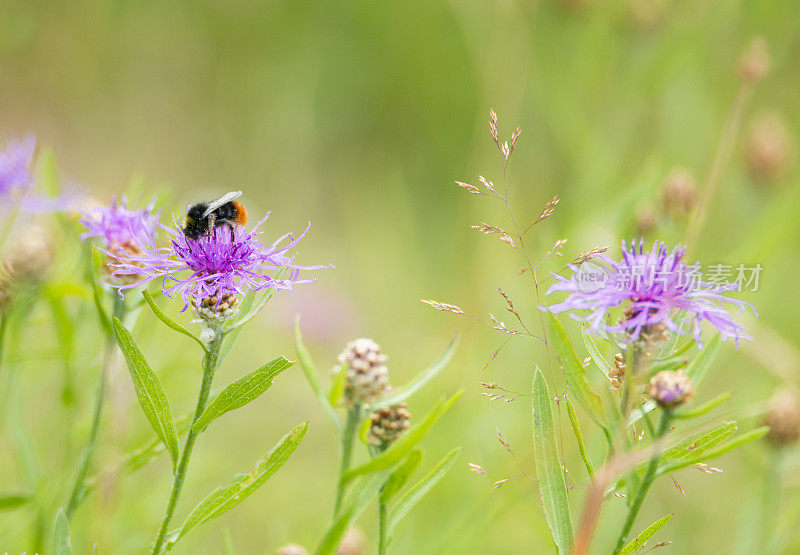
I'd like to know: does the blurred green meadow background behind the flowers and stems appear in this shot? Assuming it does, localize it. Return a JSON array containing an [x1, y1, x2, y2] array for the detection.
[[0, 0, 800, 554]]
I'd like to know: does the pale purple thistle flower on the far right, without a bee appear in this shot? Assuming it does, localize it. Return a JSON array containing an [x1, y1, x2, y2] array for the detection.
[[547, 239, 758, 345]]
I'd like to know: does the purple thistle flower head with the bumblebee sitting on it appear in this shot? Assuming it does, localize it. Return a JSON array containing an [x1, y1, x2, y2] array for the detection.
[[111, 213, 331, 310]]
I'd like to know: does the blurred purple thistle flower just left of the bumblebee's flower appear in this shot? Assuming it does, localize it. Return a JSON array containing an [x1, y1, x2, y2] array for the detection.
[[80, 197, 160, 250]]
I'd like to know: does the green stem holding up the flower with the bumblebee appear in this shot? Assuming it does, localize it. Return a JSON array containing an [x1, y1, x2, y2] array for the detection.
[[151, 329, 225, 555]]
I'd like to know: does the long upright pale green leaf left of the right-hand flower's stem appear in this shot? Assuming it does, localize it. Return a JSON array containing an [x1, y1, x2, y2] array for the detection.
[[533, 367, 573, 553]]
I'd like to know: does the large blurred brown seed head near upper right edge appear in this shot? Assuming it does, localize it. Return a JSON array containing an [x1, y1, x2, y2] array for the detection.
[[744, 111, 794, 181]]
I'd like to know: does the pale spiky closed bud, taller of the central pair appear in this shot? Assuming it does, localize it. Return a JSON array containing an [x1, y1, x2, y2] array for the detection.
[[338, 337, 389, 406]]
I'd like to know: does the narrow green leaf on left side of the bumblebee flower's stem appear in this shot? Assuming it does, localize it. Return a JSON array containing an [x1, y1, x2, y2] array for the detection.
[[112, 316, 178, 467]]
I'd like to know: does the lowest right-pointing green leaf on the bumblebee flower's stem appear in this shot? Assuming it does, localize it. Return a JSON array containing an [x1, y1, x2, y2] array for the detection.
[[167, 422, 308, 548]]
